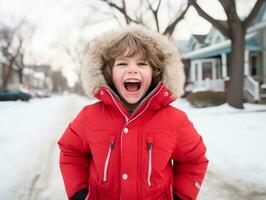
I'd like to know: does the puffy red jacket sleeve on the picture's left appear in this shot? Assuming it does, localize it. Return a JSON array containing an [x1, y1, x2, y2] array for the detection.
[[58, 108, 91, 199]]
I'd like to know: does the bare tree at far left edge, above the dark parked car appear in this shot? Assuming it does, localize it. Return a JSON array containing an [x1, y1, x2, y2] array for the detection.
[[0, 20, 34, 88]]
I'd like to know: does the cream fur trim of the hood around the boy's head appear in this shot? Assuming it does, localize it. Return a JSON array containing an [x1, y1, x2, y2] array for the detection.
[[81, 25, 185, 98]]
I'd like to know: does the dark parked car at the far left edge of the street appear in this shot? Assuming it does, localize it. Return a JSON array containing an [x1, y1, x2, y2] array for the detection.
[[0, 89, 32, 101]]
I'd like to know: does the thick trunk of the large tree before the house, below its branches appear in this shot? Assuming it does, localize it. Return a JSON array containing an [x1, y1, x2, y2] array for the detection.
[[227, 22, 245, 109]]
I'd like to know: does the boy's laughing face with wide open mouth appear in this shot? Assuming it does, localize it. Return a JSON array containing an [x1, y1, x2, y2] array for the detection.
[[112, 54, 152, 104]]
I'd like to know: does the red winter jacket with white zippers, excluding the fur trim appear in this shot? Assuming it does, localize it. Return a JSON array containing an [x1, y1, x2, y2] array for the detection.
[[58, 83, 208, 200]]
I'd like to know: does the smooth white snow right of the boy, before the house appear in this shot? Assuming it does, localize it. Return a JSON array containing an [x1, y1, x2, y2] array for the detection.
[[173, 100, 266, 199]]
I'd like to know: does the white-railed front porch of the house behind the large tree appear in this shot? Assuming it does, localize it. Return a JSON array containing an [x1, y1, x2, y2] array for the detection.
[[182, 30, 266, 102]]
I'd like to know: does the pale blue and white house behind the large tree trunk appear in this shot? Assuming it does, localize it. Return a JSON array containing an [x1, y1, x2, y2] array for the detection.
[[182, 4, 266, 101]]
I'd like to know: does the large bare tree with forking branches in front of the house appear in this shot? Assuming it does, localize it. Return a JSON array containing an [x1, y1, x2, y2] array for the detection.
[[189, 0, 265, 108]]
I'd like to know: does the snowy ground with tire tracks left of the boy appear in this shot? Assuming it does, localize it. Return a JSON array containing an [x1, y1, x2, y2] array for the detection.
[[0, 96, 88, 200]]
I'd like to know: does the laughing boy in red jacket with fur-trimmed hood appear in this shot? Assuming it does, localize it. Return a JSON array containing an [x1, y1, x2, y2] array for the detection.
[[58, 26, 208, 200]]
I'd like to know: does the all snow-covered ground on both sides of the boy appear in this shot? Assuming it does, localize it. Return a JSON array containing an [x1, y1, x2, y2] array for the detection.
[[0, 95, 266, 200]]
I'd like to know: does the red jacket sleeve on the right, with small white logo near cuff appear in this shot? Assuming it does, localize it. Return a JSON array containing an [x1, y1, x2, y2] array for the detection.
[[173, 114, 208, 200]]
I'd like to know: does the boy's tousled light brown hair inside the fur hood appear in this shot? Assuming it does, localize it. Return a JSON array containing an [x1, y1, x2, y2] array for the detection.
[[102, 32, 165, 87]]
